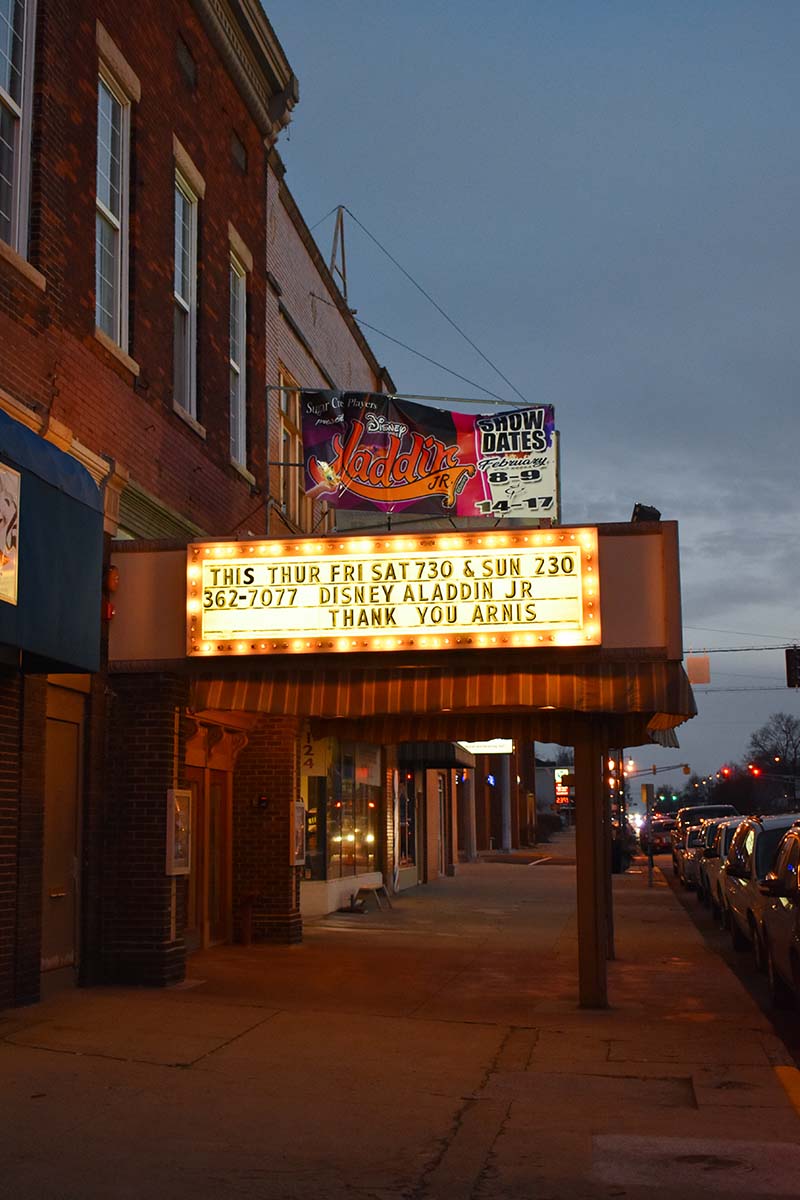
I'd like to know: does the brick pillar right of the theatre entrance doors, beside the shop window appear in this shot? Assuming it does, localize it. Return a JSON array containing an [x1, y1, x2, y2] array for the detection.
[[234, 716, 302, 943]]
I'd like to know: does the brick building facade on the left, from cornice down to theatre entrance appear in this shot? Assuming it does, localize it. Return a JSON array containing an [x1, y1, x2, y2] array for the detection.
[[0, 0, 391, 1007]]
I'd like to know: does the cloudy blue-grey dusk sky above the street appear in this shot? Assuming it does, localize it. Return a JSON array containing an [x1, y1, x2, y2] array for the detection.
[[265, 0, 800, 785]]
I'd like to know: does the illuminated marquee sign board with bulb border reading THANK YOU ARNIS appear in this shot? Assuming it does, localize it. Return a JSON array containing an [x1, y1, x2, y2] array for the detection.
[[187, 529, 600, 656]]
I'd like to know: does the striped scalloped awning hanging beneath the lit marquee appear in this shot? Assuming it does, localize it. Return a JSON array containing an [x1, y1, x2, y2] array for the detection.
[[191, 660, 697, 745]]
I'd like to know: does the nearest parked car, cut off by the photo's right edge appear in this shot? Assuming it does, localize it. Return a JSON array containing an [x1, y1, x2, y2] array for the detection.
[[760, 824, 800, 1008]]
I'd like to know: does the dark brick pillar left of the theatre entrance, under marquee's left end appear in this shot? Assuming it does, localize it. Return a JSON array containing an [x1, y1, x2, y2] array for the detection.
[[102, 674, 188, 986]]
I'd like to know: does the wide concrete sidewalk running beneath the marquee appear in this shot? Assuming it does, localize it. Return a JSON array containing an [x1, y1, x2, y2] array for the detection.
[[0, 833, 800, 1200]]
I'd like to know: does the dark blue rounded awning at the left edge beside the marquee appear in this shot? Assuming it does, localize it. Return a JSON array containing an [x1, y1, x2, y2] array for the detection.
[[0, 409, 103, 672]]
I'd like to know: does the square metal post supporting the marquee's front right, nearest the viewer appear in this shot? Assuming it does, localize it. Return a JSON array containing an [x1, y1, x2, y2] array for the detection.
[[575, 721, 608, 1008]]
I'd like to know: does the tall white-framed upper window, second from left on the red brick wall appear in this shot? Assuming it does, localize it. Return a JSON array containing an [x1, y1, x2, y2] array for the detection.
[[95, 71, 131, 349]]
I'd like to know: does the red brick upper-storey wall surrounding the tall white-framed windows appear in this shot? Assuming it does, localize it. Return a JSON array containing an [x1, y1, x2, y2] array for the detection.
[[0, 0, 272, 535]]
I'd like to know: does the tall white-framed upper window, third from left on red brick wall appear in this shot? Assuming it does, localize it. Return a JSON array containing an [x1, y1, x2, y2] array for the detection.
[[173, 173, 198, 418]]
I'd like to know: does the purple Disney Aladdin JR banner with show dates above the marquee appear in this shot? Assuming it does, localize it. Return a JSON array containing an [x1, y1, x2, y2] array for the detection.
[[302, 391, 558, 521]]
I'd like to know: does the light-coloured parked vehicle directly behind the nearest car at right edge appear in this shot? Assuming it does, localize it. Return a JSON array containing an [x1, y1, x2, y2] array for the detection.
[[722, 812, 800, 970]]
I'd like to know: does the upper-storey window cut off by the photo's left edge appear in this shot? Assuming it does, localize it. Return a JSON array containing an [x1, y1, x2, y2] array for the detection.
[[0, 0, 35, 256]]
